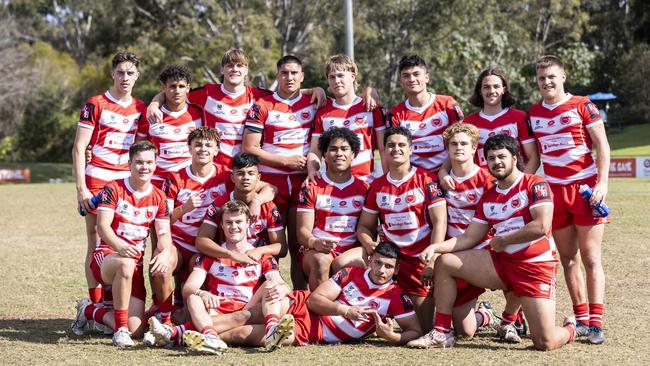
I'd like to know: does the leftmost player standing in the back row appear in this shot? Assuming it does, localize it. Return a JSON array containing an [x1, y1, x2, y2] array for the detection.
[[72, 51, 145, 314]]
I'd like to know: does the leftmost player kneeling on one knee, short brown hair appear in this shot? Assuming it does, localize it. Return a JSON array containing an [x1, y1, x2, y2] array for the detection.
[[71, 141, 176, 347]]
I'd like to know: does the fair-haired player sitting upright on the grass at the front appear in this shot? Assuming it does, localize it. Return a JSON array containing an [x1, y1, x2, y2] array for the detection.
[[149, 201, 288, 354]]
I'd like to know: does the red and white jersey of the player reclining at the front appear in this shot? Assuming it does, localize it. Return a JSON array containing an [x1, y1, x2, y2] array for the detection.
[[319, 267, 415, 343]]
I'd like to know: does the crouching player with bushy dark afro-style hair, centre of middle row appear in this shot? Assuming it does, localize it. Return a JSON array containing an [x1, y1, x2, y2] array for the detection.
[[297, 127, 369, 290]]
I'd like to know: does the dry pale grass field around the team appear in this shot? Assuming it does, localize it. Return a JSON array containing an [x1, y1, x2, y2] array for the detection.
[[0, 179, 650, 365]]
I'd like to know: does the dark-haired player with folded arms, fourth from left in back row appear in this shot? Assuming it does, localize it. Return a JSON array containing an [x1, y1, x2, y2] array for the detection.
[[243, 55, 316, 288]]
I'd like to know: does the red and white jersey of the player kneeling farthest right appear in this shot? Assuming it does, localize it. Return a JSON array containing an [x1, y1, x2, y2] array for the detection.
[[472, 173, 555, 262]]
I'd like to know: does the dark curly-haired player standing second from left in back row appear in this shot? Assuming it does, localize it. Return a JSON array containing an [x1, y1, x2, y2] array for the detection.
[[138, 64, 202, 187]]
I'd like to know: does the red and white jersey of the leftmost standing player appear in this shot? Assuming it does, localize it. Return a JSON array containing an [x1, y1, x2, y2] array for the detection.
[[77, 91, 146, 173]]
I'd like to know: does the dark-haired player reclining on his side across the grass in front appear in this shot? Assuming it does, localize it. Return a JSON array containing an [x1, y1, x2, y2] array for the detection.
[[201, 242, 422, 351]]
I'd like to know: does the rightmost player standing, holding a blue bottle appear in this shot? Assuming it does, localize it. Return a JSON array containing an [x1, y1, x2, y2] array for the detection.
[[528, 56, 610, 344]]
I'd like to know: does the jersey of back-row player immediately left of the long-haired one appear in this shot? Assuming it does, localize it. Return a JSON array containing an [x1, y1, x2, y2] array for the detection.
[[388, 93, 463, 171]]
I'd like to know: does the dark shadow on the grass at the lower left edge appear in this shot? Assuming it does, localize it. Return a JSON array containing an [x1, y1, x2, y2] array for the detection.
[[0, 319, 70, 344]]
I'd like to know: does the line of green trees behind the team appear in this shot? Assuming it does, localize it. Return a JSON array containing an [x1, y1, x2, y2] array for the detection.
[[0, 0, 650, 162]]
